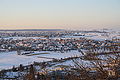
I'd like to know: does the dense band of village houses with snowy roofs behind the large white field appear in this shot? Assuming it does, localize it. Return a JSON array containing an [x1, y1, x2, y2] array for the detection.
[[0, 31, 120, 52]]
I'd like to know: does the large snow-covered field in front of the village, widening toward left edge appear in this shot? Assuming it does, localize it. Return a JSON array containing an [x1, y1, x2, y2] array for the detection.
[[0, 51, 81, 70]]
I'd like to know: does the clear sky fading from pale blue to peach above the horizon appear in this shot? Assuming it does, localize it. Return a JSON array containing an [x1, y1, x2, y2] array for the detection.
[[0, 0, 120, 30]]
